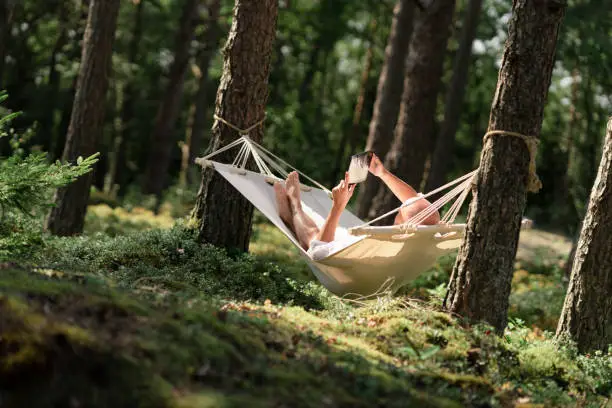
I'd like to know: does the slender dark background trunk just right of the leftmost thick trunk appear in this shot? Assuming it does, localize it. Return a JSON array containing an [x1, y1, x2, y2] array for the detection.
[[108, 0, 146, 196]]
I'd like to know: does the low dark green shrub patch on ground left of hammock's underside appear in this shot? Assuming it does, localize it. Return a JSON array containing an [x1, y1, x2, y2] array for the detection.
[[35, 226, 331, 309]]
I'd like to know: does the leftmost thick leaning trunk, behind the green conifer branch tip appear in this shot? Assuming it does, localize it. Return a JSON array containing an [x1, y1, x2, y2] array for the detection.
[[46, 0, 120, 235]]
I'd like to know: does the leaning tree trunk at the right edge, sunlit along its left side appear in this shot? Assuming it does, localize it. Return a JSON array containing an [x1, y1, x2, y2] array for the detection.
[[557, 119, 612, 352]]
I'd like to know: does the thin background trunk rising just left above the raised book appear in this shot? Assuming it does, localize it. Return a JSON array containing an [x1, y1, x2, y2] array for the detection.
[[330, 22, 376, 184]]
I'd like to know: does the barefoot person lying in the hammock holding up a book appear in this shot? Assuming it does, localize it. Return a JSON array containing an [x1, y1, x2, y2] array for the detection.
[[274, 155, 440, 260]]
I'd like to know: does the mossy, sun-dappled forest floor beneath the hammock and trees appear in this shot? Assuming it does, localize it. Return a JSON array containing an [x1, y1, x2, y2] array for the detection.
[[0, 205, 612, 407]]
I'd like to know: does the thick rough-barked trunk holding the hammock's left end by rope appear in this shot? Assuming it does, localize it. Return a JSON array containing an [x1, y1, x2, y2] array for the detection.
[[192, 0, 278, 251]]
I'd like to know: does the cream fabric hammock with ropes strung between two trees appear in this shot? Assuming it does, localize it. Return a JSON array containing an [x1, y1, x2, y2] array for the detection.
[[196, 135, 476, 296]]
